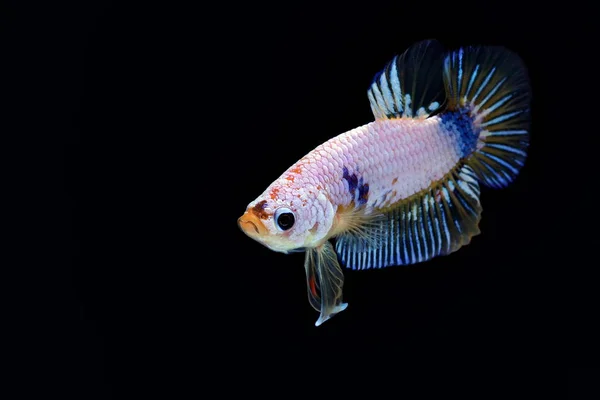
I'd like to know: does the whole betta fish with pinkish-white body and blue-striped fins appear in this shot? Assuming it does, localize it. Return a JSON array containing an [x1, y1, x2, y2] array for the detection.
[[238, 40, 531, 326]]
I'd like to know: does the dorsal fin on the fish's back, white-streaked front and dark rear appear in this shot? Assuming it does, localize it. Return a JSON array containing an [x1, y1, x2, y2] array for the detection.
[[367, 40, 444, 119]]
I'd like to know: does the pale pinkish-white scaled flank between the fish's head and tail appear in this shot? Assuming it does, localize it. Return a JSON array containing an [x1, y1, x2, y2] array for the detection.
[[274, 117, 460, 212]]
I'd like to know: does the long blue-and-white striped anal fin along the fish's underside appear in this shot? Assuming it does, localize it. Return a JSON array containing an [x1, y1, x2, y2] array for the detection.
[[336, 165, 481, 269]]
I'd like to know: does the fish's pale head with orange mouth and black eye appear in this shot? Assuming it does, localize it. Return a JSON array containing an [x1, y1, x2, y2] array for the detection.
[[238, 179, 335, 253]]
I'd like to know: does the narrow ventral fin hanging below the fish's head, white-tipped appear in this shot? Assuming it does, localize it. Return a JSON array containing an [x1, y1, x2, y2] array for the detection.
[[304, 242, 348, 326]]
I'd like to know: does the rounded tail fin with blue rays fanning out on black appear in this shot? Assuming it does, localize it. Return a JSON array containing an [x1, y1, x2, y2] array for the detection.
[[443, 47, 531, 188]]
